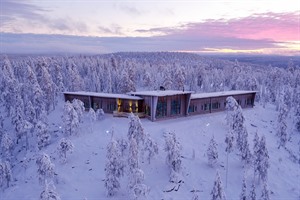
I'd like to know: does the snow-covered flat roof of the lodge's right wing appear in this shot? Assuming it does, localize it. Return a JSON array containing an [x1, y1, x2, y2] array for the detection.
[[191, 90, 256, 99]]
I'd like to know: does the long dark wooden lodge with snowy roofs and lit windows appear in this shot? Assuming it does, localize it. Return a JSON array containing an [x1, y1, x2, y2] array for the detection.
[[64, 90, 256, 121]]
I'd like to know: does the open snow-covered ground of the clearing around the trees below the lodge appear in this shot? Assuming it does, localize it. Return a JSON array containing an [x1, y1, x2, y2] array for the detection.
[[0, 103, 300, 200]]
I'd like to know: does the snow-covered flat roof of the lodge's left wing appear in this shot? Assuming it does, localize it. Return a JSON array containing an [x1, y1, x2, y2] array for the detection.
[[64, 91, 143, 100]]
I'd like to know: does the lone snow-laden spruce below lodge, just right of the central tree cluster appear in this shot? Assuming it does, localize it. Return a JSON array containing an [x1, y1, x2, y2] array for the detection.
[[164, 132, 182, 182]]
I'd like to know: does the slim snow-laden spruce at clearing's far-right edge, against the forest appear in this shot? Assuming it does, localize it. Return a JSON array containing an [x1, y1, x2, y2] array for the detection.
[[276, 104, 288, 149]]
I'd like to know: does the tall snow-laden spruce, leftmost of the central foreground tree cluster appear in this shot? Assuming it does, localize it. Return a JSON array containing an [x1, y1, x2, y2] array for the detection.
[[104, 138, 125, 196]]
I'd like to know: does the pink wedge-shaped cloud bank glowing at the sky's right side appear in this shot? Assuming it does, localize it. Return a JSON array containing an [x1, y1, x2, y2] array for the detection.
[[137, 11, 300, 41]]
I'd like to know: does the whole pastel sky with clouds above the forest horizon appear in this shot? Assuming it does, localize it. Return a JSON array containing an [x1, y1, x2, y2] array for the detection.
[[0, 0, 300, 55]]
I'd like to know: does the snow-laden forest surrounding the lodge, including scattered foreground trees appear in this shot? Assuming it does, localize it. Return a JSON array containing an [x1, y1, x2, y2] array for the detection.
[[0, 52, 300, 199]]
